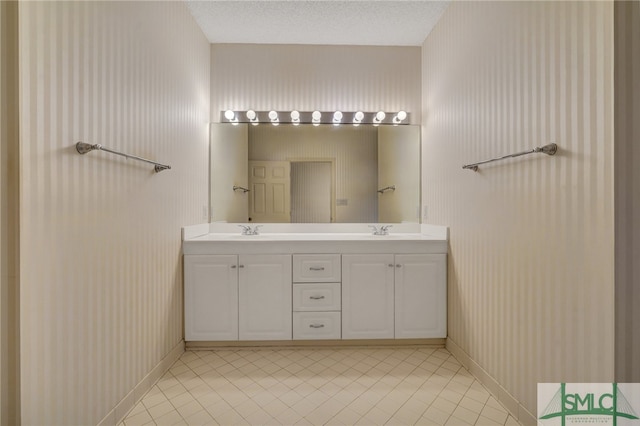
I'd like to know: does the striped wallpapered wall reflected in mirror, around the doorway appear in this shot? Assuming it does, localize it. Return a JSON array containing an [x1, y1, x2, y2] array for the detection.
[[249, 125, 378, 223]]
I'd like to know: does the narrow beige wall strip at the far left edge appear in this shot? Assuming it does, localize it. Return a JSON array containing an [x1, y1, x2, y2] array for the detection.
[[0, 1, 20, 425]]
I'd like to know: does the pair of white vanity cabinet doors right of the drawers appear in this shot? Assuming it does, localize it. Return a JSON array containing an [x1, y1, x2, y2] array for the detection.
[[342, 254, 447, 339]]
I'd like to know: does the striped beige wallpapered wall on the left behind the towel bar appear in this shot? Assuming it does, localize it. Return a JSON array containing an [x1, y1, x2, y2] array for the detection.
[[19, 1, 210, 425]]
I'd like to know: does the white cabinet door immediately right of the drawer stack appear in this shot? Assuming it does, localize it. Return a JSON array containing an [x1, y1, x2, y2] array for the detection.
[[342, 254, 395, 339]]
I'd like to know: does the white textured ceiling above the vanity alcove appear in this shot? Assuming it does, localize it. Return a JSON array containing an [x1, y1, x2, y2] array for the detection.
[[185, 0, 449, 46]]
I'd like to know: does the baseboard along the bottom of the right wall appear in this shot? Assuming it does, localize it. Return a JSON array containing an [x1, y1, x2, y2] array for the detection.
[[446, 337, 538, 426]]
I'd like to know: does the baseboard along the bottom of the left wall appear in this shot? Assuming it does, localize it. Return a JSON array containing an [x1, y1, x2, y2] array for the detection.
[[98, 340, 184, 426]]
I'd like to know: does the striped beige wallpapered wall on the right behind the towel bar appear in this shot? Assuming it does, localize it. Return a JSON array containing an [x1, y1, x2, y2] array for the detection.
[[422, 2, 614, 423]]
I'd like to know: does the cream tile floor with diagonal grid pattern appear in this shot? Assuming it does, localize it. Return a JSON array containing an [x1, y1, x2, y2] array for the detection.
[[120, 347, 519, 426]]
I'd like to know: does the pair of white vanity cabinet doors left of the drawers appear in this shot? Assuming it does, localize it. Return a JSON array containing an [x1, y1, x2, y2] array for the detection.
[[184, 255, 292, 341]]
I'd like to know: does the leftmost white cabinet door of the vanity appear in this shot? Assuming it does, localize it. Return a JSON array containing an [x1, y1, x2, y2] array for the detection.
[[184, 255, 238, 341]]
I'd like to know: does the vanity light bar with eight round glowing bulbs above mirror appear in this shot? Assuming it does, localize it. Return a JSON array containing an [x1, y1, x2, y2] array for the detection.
[[220, 110, 411, 126]]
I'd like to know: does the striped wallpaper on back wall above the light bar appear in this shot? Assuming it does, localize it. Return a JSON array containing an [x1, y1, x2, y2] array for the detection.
[[211, 44, 421, 124]]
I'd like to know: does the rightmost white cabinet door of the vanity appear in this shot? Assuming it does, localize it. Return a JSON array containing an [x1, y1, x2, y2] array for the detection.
[[395, 254, 447, 339]]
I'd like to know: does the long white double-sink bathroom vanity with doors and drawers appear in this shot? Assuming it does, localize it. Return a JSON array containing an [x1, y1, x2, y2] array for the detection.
[[183, 223, 447, 343]]
